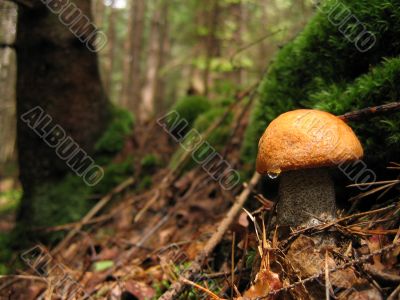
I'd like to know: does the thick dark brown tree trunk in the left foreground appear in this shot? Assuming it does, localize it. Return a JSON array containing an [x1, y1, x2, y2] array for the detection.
[[16, 0, 110, 230]]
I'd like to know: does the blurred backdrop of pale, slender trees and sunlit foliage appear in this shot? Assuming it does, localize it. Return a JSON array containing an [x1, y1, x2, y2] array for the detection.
[[93, 0, 313, 121]]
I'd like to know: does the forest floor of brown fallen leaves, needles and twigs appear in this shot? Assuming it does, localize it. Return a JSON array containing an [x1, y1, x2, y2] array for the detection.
[[0, 95, 400, 300]]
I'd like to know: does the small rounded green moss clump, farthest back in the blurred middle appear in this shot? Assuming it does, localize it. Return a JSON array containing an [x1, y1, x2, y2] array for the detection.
[[169, 96, 211, 128]]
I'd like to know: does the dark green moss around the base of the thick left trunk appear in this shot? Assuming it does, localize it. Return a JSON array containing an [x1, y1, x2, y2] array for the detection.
[[16, 108, 134, 246]]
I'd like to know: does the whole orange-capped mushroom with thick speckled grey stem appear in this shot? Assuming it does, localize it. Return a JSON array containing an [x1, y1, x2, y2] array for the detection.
[[256, 109, 363, 227]]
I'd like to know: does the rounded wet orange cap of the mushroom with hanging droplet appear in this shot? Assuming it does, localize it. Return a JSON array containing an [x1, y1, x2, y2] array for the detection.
[[256, 109, 363, 174]]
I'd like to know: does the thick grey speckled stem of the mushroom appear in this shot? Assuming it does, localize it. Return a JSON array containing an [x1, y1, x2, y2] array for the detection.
[[277, 168, 336, 227]]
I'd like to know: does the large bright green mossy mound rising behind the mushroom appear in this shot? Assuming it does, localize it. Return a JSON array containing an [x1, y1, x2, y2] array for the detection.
[[242, 0, 400, 169]]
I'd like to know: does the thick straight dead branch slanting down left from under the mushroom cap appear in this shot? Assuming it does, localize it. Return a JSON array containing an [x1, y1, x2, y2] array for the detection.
[[159, 173, 261, 300]]
